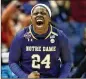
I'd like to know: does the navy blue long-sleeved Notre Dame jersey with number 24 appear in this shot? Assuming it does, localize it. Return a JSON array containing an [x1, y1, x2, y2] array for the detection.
[[9, 26, 71, 78]]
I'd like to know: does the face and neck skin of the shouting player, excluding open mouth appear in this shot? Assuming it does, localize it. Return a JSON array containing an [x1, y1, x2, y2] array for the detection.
[[31, 6, 51, 35]]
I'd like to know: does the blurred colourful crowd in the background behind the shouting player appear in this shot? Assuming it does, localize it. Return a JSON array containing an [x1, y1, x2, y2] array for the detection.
[[1, 0, 86, 78]]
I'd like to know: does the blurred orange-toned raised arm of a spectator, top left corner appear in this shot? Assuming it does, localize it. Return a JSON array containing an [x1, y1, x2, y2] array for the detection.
[[2, 1, 18, 23]]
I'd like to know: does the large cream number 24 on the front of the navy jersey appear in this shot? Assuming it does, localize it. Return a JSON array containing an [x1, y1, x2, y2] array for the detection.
[[32, 54, 50, 69]]
